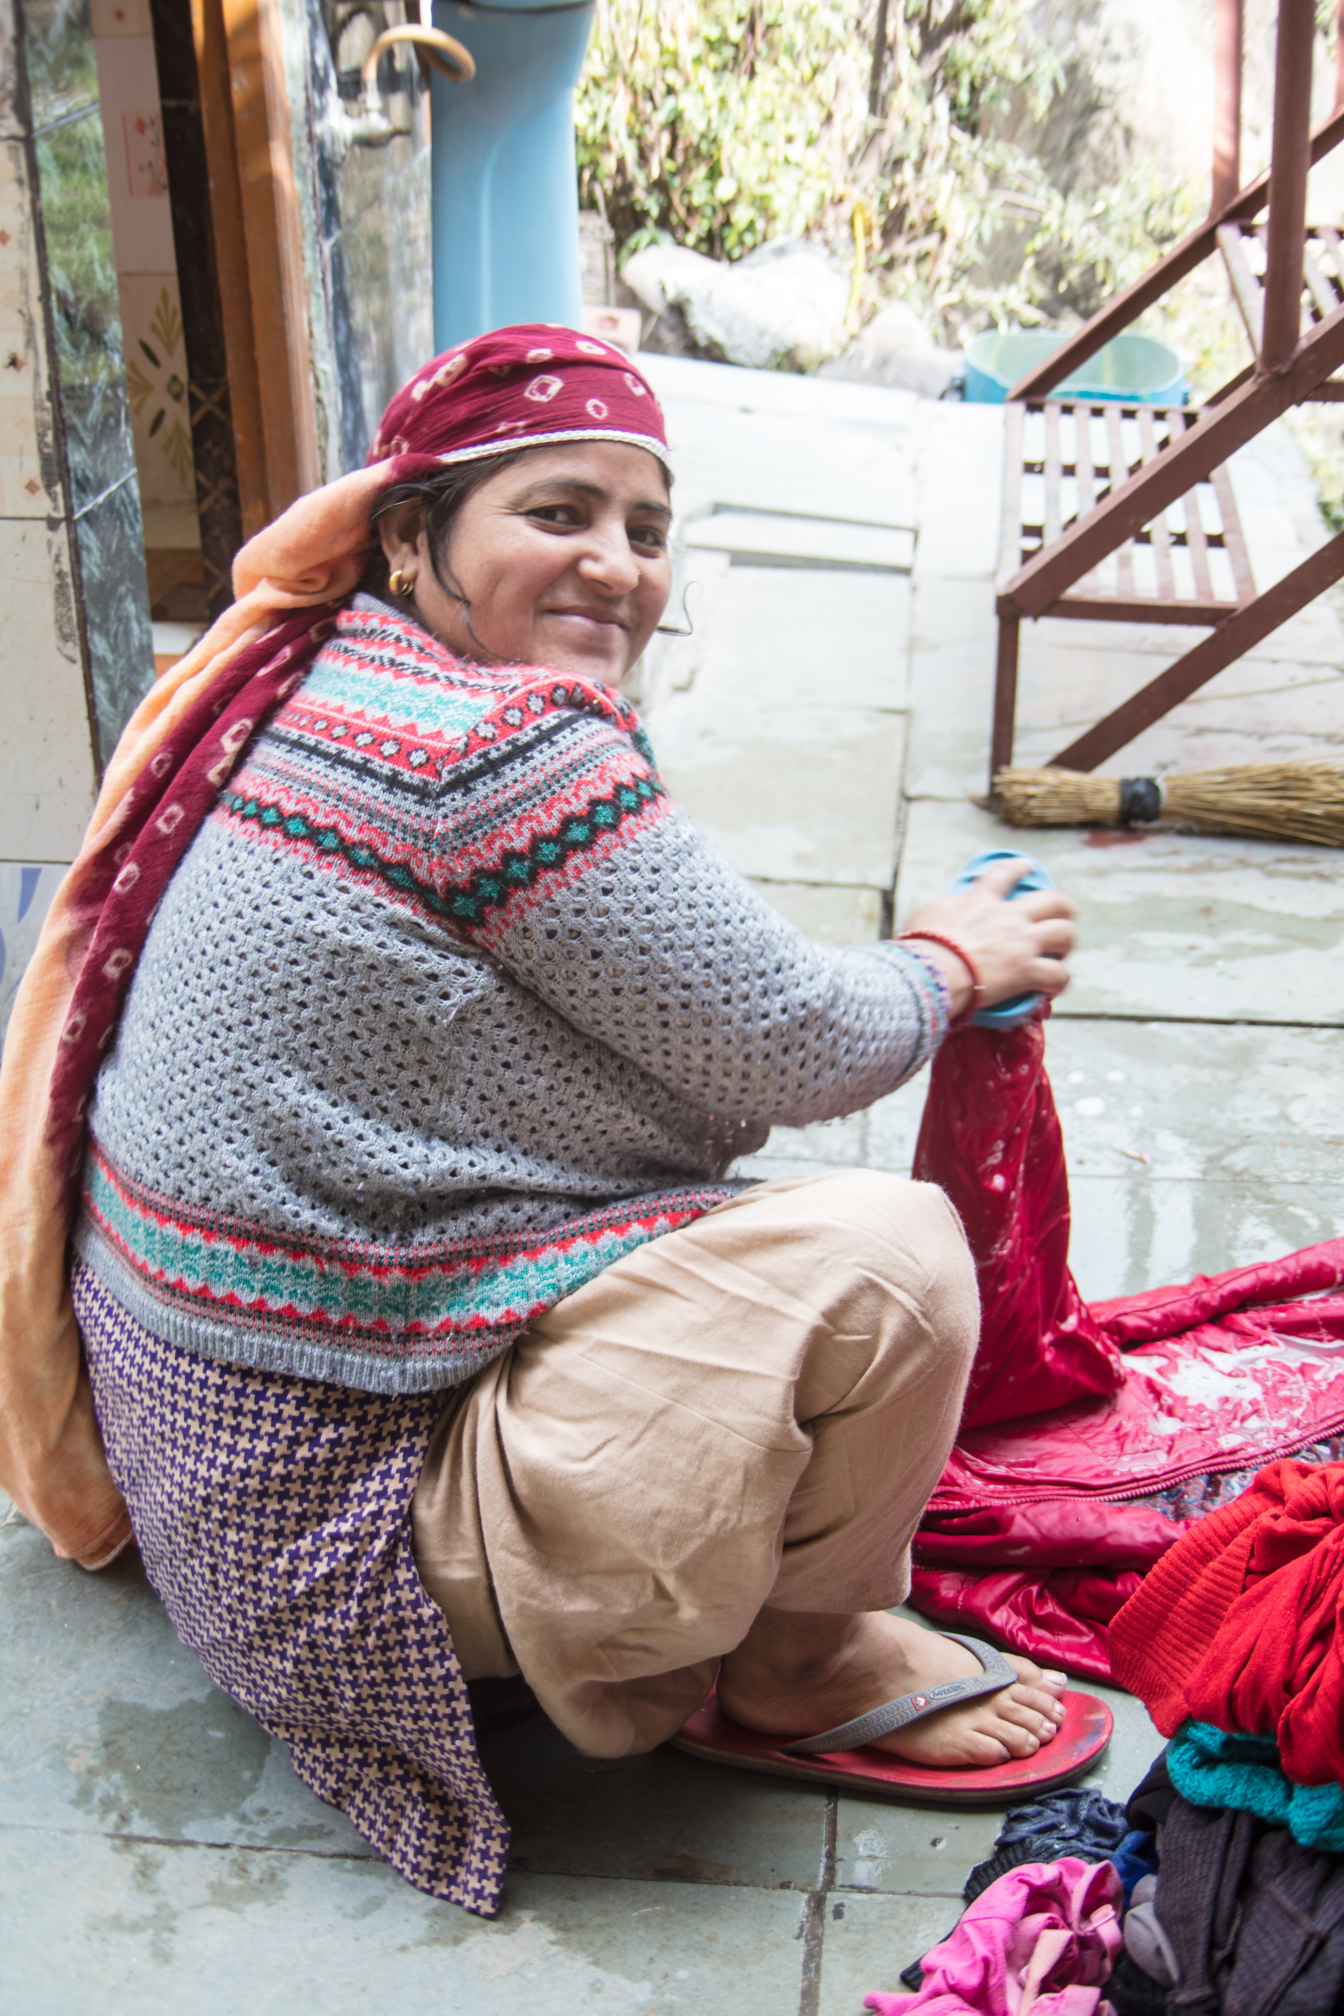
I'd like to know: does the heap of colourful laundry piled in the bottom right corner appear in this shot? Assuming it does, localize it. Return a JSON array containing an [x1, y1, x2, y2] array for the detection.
[[864, 1462, 1344, 2016]]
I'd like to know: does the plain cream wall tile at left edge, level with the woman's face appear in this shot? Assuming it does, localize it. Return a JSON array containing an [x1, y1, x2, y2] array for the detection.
[[0, 518, 93, 861]]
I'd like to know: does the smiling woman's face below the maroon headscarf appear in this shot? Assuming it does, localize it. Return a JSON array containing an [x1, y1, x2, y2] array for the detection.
[[383, 442, 671, 685]]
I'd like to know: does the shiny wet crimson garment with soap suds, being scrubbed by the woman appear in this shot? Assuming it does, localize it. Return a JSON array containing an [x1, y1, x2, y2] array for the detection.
[[911, 1024, 1344, 1679]]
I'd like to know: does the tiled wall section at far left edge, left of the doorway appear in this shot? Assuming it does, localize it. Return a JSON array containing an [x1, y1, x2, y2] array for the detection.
[[0, 0, 153, 1028]]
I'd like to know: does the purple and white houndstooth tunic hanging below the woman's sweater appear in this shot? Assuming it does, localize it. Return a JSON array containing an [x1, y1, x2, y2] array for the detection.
[[75, 1266, 508, 1917]]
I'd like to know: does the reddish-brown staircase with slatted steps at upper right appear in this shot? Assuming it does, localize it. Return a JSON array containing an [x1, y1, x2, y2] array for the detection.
[[989, 0, 1344, 794]]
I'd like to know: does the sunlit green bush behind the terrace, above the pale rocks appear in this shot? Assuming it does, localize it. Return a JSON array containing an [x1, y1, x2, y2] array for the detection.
[[578, 0, 1191, 343]]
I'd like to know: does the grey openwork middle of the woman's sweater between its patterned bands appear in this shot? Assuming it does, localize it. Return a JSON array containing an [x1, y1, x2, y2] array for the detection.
[[93, 794, 935, 1250]]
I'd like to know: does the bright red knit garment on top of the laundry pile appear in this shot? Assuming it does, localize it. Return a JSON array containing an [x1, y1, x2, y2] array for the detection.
[[1110, 1462, 1344, 1784]]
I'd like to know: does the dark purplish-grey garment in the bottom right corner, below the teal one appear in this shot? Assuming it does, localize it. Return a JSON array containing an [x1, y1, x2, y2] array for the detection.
[[1155, 1798, 1344, 2016]]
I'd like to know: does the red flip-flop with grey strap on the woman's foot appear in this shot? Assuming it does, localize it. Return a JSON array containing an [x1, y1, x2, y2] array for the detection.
[[673, 1631, 1114, 1806]]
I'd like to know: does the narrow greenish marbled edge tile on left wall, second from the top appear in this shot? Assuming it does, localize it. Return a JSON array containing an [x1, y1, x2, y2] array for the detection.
[[36, 107, 135, 512]]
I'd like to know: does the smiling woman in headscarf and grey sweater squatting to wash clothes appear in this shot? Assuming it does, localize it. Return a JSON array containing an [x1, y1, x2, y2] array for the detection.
[[0, 327, 1088, 1913]]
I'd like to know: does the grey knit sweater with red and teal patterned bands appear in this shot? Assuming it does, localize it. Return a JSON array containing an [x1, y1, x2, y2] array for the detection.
[[77, 597, 947, 1391]]
